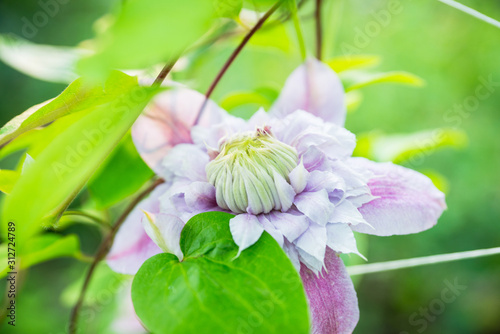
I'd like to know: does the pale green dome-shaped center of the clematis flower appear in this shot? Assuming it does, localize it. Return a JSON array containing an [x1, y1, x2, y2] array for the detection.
[[206, 128, 298, 215]]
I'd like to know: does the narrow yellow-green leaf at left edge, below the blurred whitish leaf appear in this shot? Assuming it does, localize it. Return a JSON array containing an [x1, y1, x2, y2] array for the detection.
[[0, 71, 137, 146]]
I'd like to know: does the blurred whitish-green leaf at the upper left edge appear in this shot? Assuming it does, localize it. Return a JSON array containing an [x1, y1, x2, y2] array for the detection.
[[0, 35, 85, 83]]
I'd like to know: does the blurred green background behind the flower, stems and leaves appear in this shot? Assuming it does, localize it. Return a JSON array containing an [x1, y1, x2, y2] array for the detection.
[[0, 0, 500, 333]]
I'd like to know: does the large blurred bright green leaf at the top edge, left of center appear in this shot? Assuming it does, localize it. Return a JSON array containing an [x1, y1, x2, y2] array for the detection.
[[79, 0, 216, 78]]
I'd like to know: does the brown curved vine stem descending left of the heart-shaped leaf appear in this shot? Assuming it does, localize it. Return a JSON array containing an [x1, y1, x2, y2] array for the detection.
[[68, 179, 165, 334]]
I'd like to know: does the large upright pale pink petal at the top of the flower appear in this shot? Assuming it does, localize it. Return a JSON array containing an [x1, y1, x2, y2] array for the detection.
[[271, 58, 346, 126]]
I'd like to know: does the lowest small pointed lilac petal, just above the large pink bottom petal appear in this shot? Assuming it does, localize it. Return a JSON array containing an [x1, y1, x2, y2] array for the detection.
[[294, 222, 327, 272]]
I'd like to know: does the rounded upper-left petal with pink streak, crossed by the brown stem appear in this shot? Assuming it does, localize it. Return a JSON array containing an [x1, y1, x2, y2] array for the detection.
[[132, 88, 226, 174]]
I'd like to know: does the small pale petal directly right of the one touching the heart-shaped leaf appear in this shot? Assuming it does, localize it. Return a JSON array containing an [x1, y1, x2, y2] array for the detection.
[[266, 210, 309, 242]]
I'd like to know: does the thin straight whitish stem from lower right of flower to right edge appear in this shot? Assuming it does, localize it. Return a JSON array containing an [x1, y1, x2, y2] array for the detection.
[[347, 247, 500, 276]]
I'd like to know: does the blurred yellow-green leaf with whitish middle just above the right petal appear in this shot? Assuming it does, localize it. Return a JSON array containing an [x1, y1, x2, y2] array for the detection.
[[354, 128, 467, 164]]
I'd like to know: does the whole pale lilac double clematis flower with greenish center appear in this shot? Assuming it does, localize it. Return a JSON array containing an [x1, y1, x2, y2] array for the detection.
[[107, 59, 446, 334]]
